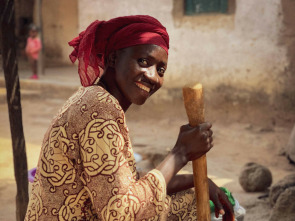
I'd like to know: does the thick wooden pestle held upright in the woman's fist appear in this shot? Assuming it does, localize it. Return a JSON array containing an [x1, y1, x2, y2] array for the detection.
[[182, 84, 211, 221]]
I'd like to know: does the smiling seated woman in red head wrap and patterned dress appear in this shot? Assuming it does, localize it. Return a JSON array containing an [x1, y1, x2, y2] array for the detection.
[[26, 16, 233, 220]]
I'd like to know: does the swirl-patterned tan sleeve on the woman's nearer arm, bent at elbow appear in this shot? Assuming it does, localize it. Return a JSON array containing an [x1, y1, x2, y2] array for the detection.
[[75, 101, 166, 220]]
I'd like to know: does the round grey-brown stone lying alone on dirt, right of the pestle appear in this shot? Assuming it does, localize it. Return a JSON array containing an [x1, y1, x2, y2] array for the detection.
[[239, 162, 272, 192]]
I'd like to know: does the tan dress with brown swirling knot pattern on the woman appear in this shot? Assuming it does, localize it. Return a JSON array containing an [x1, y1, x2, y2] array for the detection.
[[25, 86, 196, 221]]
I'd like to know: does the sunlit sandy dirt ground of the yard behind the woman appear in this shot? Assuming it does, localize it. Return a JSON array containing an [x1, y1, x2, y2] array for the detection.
[[0, 77, 295, 221]]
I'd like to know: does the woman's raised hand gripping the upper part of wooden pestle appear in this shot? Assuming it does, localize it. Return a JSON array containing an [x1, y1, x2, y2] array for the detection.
[[172, 123, 213, 164]]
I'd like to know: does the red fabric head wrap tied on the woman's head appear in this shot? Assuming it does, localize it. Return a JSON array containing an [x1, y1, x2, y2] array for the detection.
[[69, 15, 169, 87]]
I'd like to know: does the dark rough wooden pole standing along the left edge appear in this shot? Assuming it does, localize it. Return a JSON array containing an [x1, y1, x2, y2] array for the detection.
[[0, 0, 29, 221]]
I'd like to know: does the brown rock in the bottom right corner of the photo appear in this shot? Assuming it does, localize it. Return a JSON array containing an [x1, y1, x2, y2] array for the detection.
[[269, 186, 295, 221]]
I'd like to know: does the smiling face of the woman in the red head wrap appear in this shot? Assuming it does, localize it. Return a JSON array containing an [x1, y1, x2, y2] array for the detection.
[[115, 45, 168, 105]]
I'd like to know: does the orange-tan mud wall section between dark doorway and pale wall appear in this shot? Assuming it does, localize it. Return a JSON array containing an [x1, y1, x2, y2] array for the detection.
[[42, 0, 78, 66]]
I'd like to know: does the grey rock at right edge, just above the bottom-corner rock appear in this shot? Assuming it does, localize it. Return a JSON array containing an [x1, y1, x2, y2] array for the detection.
[[269, 173, 295, 206]]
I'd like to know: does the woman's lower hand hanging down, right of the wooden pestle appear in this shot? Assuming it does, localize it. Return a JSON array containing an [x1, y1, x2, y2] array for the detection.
[[208, 178, 235, 221]]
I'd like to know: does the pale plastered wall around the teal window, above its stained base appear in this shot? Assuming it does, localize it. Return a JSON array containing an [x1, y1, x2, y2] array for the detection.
[[78, 0, 294, 105]]
